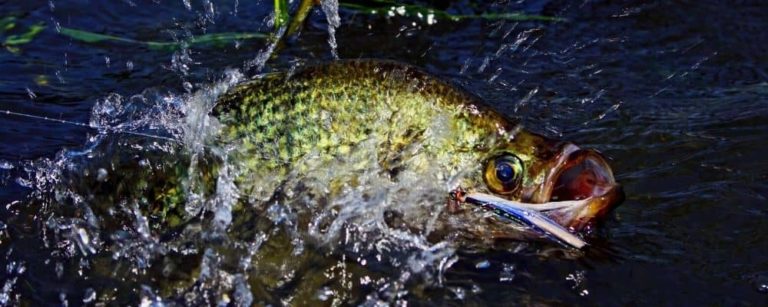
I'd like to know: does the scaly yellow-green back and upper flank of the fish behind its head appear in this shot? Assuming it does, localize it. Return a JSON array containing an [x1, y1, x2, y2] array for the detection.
[[214, 61, 498, 203]]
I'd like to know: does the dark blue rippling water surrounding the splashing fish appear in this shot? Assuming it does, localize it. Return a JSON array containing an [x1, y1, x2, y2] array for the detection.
[[0, 1, 768, 305]]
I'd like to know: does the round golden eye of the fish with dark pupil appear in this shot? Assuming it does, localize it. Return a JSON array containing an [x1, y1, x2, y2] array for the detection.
[[483, 153, 523, 194]]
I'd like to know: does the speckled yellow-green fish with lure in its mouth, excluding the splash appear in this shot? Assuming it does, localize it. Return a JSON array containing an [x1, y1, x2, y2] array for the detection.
[[213, 60, 624, 248]]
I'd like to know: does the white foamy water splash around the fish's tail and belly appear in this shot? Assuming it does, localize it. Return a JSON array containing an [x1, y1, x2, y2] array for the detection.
[[12, 59, 472, 304]]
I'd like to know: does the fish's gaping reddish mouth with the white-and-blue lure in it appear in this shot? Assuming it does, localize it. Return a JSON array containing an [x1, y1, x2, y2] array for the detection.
[[451, 144, 624, 248]]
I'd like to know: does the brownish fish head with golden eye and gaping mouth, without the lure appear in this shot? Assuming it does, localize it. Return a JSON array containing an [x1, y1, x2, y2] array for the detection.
[[452, 129, 624, 231]]
